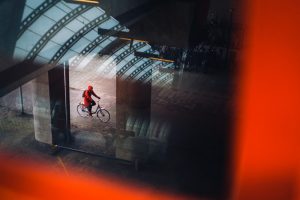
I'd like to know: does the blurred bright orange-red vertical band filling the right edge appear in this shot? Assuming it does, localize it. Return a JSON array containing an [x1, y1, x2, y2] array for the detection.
[[232, 0, 300, 200]]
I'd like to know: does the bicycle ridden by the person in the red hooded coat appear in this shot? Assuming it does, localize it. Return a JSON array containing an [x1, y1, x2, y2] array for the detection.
[[77, 100, 110, 123]]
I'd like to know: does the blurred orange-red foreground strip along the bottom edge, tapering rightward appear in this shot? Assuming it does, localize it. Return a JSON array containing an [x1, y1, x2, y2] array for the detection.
[[0, 155, 192, 200]]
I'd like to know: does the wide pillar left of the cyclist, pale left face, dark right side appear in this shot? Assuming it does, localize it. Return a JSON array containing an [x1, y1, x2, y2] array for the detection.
[[32, 65, 70, 145]]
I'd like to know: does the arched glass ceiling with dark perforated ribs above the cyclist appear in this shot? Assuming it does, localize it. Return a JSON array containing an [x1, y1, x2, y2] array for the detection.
[[14, 0, 174, 85]]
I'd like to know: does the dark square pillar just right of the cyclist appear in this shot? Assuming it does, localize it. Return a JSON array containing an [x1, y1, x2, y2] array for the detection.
[[116, 77, 151, 161]]
